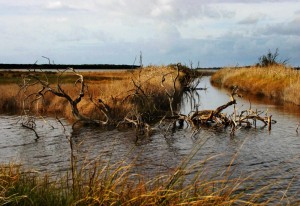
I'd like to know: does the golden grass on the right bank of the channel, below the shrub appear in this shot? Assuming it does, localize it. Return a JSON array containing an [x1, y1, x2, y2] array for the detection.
[[211, 64, 300, 105]]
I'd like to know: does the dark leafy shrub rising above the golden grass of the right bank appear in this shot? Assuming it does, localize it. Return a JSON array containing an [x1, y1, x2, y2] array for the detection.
[[257, 48, 288, 67]]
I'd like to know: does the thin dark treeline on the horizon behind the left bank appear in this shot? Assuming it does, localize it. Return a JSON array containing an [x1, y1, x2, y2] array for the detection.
[[0, 64, 140, 70]]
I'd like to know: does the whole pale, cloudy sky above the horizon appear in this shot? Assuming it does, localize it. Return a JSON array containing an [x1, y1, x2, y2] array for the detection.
[[0, 0, 300, 67]]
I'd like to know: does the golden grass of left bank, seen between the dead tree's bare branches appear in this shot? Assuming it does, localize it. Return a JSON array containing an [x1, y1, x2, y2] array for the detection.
[[0, 66, 183, 120]]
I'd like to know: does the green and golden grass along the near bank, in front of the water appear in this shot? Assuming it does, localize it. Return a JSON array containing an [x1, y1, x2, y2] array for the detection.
[[0, 162, 284, 205]]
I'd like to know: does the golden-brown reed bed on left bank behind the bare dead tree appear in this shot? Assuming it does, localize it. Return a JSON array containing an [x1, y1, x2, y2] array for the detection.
[[0, 66, 184, 125]]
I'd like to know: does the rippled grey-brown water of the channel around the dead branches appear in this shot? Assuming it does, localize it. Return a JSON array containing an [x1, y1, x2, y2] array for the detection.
[[0, 77, 300, 199]]
